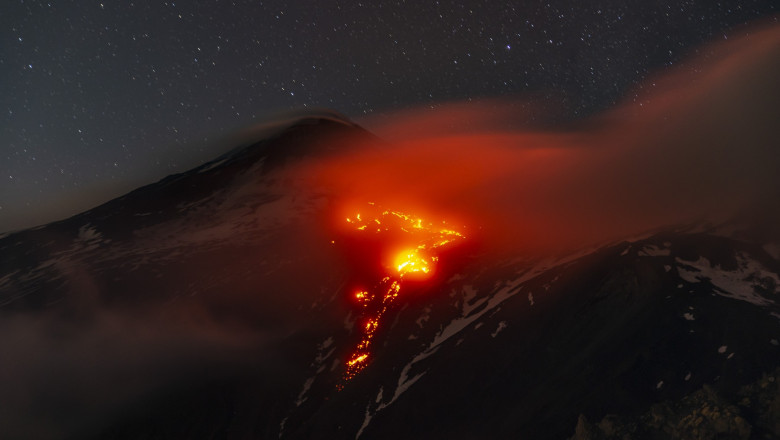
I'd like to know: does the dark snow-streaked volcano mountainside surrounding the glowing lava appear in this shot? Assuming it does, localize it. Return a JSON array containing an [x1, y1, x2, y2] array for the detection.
[[0, 111, 780, 439]]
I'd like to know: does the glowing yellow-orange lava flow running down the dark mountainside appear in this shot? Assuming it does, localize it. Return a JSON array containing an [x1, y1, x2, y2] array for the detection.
[[344, 203, 465, 381]]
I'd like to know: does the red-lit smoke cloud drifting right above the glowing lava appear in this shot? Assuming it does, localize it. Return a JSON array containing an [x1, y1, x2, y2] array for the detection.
[[302, 26, 780, 252]]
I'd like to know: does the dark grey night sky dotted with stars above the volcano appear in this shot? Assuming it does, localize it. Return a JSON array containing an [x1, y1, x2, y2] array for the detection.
[[0, 0, 778, 232]]
